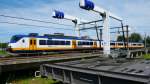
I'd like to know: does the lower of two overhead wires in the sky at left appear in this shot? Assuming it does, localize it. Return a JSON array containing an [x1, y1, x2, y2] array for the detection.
[[0, 22, 73, 30]]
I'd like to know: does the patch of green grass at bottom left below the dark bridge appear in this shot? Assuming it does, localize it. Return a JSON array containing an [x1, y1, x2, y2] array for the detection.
[[9, 77, 58, 84]]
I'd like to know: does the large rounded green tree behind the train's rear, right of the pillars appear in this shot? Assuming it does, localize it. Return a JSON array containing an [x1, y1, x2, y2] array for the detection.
[[129, 33, 142, 42]]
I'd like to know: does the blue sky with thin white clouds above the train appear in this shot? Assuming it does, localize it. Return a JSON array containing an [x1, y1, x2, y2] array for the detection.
[[0, 0, 150, 42]]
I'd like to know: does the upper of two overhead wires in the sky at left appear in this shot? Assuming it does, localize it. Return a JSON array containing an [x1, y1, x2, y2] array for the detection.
[[0, 15, 73, 26]]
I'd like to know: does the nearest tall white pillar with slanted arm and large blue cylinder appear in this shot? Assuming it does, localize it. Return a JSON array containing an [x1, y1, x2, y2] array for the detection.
[[79, 0, 122, 56]]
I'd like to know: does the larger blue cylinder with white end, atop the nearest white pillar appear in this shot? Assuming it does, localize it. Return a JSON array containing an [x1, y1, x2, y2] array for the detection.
[[80, 0, 94, 10]]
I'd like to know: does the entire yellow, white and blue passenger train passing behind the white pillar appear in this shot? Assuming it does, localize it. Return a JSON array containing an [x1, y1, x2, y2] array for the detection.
[[8, 33, 144, 53]]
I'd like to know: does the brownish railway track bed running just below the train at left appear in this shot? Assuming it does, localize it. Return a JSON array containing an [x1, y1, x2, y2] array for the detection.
[[0, 53, 102, 63]]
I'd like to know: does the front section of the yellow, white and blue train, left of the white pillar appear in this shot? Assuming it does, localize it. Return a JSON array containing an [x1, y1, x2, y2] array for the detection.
[[8, 35, 98, 53]]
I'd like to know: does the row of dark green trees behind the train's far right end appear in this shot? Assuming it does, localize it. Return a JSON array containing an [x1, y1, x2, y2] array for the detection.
[[117, 33, 150, 47]]
